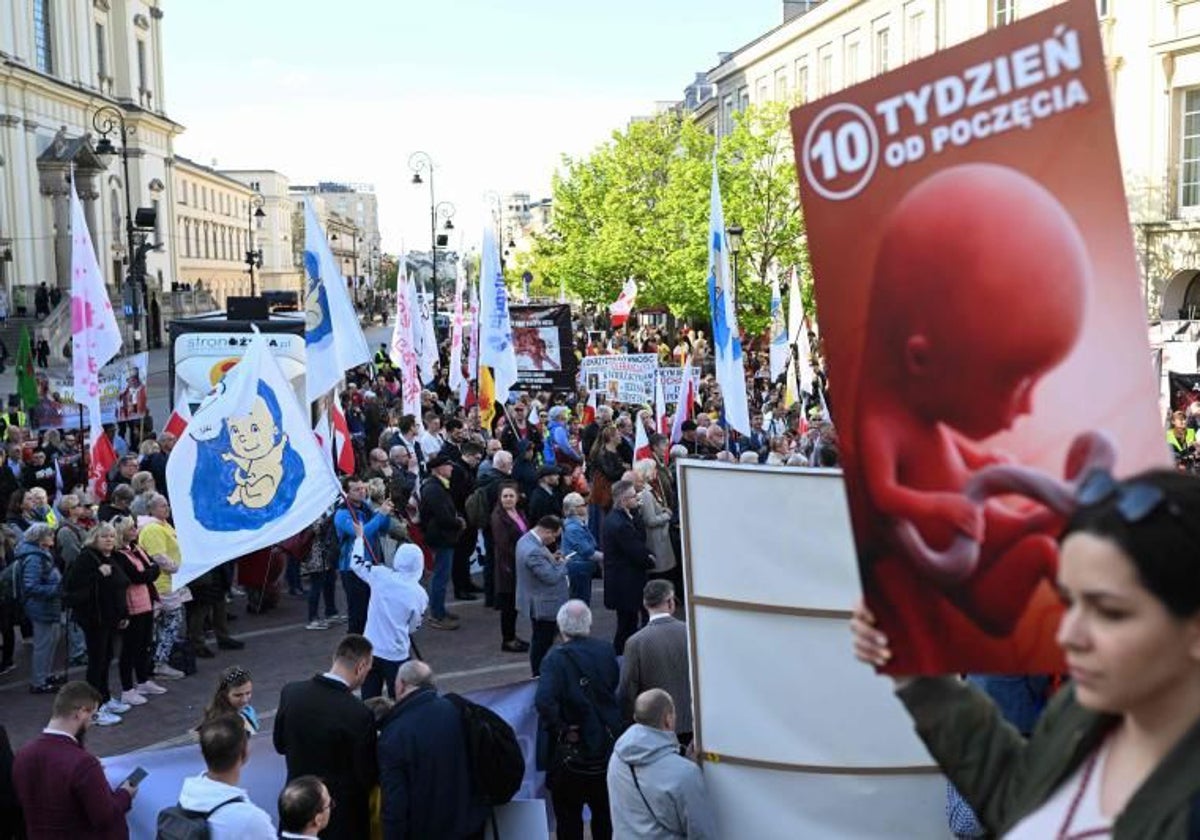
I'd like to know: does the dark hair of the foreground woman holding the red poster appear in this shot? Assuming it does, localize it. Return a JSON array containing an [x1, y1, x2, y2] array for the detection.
[[1063, 469, 1200, 618]]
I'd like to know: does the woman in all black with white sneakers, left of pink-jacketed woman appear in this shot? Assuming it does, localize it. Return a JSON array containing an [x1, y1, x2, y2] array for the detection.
[[64, 522, 132, 726]]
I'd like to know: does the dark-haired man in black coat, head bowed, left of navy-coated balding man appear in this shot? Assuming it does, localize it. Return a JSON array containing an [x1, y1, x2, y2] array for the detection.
[[274, 634, 379, 840]]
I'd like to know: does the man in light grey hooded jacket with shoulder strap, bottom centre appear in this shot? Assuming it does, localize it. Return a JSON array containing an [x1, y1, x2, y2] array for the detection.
[[608, 689, 716, 840]]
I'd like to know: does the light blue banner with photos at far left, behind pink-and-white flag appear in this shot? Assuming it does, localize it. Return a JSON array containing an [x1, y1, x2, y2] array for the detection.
[[30, 353, 150, 430]]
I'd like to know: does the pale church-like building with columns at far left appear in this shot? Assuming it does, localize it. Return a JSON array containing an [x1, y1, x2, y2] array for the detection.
[[0, 0, 182, 352]]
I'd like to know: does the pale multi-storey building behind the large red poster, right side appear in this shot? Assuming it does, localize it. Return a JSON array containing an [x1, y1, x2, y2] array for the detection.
[[696, 0, 1200, 331]]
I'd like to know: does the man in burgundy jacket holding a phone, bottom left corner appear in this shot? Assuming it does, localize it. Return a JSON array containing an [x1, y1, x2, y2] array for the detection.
[[12, 680, 138, 840]]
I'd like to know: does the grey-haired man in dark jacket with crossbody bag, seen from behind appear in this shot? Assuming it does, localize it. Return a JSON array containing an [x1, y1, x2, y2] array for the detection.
[[534, 601, 622, 840]]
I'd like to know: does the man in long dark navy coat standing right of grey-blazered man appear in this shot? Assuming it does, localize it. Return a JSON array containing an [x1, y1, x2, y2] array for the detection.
[[600, 481, 654, 656]]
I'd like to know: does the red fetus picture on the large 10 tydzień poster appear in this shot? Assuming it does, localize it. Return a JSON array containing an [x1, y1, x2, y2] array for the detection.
[[854, 163, 1091, 673]]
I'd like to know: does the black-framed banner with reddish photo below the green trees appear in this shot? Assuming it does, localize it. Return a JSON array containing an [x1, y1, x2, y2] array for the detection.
[[509, 305, 578, 391]]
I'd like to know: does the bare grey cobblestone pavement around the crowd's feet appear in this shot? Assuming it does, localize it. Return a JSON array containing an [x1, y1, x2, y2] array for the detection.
[[0, 581, 616, 756]]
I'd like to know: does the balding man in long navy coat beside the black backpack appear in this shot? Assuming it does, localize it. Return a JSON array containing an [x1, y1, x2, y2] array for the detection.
[[379, 659, 487, 840]]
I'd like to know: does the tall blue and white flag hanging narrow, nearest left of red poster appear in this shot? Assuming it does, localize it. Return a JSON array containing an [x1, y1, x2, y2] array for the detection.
[[708, 155, 750, 434]]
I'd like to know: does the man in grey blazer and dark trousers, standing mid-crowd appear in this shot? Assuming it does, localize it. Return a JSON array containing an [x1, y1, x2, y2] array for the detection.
[[516, 516, 570, 677]]
